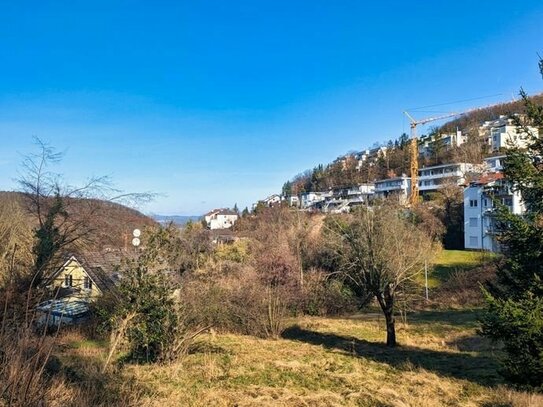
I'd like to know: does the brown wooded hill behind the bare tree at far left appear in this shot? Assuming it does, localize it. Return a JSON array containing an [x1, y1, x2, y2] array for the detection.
[[0, 191, 157, 251]]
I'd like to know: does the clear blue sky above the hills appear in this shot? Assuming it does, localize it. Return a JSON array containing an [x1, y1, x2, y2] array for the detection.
[[0, 0, 543, 214]]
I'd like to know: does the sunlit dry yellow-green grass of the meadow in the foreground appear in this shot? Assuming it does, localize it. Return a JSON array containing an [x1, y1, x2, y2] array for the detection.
[[53, 311, 543, 407]]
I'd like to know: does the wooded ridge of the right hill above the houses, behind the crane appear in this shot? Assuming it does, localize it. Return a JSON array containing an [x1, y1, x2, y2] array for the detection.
[[282, 94, 543, 195]]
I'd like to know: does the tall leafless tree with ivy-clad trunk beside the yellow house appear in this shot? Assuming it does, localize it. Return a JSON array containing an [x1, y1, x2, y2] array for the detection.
[[19, 138, 154, 285]]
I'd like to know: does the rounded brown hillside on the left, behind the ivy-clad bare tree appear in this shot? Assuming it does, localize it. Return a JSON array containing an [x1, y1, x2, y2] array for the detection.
[[0, 191, 156, 251]]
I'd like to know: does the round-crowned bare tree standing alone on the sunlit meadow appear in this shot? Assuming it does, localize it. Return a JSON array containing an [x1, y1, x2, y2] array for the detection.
[[327, 203, 434, 346]]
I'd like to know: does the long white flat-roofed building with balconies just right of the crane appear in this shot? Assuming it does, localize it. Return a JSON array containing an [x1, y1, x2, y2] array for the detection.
[[419, 163, 474, 193]]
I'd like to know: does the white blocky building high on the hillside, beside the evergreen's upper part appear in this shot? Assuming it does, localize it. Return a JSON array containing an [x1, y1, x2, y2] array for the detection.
[[479, 115, 538, 152]]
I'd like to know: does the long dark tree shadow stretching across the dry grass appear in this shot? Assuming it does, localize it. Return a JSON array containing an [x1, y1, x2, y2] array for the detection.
[[282, 325, 501, 386]]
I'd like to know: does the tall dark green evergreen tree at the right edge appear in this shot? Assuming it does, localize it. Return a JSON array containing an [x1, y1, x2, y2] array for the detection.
[[481, 61, 543, 390]]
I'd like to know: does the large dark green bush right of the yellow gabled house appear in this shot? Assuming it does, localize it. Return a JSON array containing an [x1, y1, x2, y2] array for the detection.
[[95, 256, 205, 369]]
